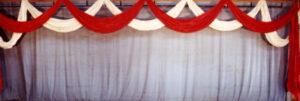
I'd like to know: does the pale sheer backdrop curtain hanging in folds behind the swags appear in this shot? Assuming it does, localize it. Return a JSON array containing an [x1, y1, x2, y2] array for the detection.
[[0, 4, 287, 101]]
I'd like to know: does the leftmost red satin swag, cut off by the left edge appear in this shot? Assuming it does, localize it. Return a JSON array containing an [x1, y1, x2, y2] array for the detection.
[[0, 0, 63, 33]]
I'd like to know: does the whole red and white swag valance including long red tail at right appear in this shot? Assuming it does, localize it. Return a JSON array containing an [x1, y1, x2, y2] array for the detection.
[[0, 0, 300, 98]]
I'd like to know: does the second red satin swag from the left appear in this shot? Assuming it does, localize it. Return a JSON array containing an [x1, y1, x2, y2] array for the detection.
[[64, 0, 145, 33]]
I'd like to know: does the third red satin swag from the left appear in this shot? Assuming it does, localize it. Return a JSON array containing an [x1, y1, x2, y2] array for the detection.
[[147, 0, 226, 33]]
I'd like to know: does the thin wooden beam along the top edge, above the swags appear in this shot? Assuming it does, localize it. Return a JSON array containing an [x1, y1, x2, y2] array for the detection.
[[0, 0, 295, 3]]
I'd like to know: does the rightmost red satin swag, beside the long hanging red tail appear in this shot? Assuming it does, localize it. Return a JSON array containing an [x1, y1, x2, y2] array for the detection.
[[227, 0, 298, 33]]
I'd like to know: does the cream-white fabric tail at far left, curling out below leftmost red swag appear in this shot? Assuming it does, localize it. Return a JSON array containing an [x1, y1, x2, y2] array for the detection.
[[0, 2, 27, 49]]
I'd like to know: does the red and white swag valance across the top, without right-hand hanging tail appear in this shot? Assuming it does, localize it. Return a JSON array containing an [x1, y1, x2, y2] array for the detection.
[[0, 0, 300, 49]]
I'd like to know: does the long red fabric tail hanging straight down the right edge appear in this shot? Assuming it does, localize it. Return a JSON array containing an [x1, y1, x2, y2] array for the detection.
[[287, 5, 300, 100]]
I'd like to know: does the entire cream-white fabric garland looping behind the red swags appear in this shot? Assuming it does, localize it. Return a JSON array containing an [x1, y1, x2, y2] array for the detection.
[[0, 0, 300, 49]]
